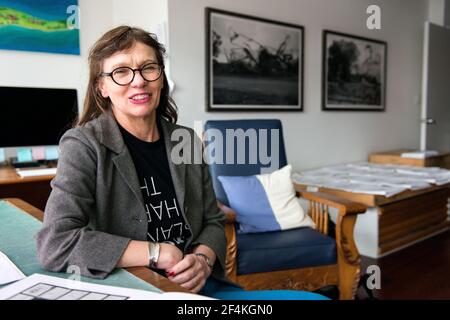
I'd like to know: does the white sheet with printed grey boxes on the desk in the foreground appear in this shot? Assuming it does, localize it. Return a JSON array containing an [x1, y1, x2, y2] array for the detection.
[[0, 273, 212, 300]]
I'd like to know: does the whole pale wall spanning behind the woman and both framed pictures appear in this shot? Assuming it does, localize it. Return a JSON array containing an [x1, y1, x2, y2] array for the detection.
[[0, 0, 433, 170]]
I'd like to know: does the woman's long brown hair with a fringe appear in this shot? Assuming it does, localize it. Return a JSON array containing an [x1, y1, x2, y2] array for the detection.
[[75, 26, 178, 126]]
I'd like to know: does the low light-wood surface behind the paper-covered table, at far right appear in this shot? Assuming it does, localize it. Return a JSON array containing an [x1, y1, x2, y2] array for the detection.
[[369, 149, 450, 169]]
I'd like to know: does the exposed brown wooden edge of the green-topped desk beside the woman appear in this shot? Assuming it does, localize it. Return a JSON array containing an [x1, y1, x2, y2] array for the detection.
[[4, 198, 190, 292]]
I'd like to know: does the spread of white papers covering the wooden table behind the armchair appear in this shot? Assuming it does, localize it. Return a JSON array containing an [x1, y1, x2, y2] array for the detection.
[[292, 162, 450, 197]]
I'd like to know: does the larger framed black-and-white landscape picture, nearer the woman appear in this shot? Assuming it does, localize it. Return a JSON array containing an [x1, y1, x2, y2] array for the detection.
[[206, 8, 304, 111]]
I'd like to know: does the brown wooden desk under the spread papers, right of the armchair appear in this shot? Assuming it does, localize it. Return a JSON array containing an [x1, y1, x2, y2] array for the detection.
[[295, 183, 450, 258]]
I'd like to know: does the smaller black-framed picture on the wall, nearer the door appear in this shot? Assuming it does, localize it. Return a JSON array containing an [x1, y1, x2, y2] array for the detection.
[[322, 30, 388, 112]]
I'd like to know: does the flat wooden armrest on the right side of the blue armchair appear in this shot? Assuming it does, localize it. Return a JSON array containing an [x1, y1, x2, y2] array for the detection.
[[297, 191, 367, 216]]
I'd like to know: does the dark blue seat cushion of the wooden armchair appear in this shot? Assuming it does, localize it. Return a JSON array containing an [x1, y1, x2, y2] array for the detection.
[[237, 228, 337, 275]]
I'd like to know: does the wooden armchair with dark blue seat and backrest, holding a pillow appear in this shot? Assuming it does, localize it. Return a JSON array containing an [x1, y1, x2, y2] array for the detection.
[[204, 120, 366, 299]]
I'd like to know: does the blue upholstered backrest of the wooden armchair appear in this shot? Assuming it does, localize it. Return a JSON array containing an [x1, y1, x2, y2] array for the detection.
[[204, 119, 287, 206]]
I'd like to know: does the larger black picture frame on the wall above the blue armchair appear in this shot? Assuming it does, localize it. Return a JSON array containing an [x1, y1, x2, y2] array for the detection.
[[205, 7, 305, 112]]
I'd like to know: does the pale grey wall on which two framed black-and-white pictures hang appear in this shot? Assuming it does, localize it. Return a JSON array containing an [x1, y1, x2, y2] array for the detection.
[[169, 0, 428, 170]]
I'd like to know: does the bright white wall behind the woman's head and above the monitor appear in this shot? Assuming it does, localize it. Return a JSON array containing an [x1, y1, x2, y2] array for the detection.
[[0, 0, 167, 157]]
